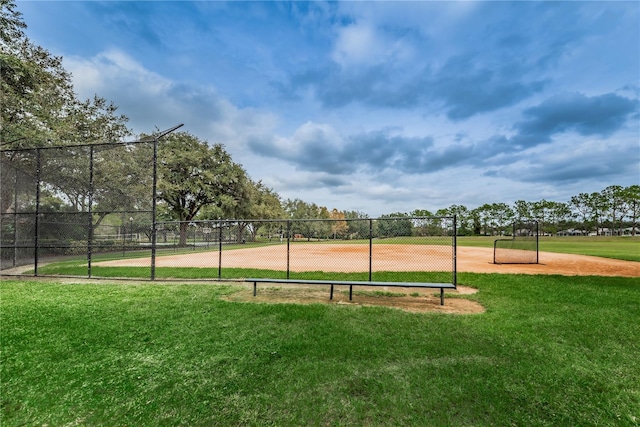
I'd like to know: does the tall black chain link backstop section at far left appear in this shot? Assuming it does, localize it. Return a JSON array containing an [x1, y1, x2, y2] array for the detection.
[[0, 141, 154, 275]]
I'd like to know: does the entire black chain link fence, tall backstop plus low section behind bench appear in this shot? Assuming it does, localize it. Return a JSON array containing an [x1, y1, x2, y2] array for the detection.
[[0, 139, 456, 284]]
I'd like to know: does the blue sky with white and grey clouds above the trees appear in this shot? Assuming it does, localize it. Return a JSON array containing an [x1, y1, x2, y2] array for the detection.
[[18, 1, 640, 216]]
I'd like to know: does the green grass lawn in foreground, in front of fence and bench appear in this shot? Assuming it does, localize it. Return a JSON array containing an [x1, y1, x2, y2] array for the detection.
[[0, 273, 640, 426]]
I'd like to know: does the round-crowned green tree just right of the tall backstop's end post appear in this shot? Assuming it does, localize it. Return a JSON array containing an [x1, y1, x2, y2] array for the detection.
[[158, 132, 247, 246]]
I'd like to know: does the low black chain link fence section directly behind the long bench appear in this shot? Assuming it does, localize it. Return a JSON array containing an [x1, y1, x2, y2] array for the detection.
[[109, 217, 456, 283]]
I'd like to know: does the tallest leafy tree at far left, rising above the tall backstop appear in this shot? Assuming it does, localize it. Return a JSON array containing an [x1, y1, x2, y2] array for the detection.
[[0, 0, 134, 225]]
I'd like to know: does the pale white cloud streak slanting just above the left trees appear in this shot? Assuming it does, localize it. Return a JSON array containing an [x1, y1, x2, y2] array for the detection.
[[65, 49, 277, 147]]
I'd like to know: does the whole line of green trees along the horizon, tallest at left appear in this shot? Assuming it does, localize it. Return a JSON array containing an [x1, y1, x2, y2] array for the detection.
[[0, 0, 640, 249]]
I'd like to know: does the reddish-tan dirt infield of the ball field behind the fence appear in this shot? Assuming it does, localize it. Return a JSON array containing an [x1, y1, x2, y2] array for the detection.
[[95, 244, 640, 277]]
